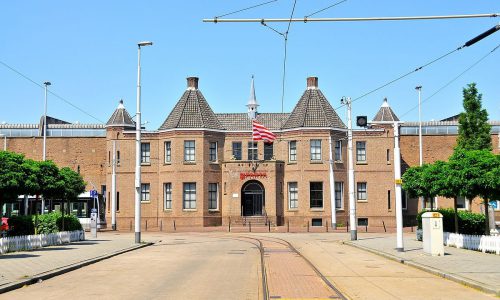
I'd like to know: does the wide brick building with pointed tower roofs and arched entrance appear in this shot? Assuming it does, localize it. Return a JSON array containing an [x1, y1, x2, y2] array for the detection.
[[0, 77, 500, 229]]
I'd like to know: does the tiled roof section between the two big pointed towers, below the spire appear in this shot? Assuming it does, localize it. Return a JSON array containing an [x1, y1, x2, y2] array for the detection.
[[215, 113, 290, 131]]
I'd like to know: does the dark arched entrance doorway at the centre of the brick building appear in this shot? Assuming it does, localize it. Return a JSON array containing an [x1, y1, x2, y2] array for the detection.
[[241, 181, 265, 216]]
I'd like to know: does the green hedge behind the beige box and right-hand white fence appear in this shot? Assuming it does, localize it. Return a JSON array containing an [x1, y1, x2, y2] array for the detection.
[[417, 208, 486, 235]]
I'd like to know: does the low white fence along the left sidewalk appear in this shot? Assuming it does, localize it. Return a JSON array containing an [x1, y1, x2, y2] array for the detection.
[[0, 230, 85, 254]]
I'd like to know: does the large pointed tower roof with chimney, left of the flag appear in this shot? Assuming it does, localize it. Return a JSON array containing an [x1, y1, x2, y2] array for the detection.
[[159, 77, 223, 130]]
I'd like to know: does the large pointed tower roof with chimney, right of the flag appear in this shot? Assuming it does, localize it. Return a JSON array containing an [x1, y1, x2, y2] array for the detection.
[[283, 77, 346, 129]]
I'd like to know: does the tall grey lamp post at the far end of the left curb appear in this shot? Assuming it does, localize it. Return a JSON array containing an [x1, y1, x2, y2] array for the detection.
[[135, 42, 153, 244]]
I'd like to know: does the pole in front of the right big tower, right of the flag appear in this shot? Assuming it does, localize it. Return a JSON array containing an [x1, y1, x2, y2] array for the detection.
[[340, 97, 358, 241]]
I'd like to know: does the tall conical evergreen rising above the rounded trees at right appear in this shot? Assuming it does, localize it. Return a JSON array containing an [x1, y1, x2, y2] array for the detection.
[[456, 83, 492, 150]]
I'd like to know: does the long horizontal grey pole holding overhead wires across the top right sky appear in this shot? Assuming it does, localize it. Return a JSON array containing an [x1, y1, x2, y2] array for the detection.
[[203, 13, 500, 23]]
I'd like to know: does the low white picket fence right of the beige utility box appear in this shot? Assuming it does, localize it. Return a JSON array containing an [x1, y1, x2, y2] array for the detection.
[[443, 232, 500, 255]]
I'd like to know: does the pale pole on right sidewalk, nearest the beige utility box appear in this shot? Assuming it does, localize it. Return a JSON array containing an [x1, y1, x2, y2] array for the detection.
[[394, 122, 404, 252]]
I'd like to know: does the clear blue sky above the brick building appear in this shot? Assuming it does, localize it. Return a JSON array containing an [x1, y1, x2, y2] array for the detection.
[[0, 0, 500, 130]]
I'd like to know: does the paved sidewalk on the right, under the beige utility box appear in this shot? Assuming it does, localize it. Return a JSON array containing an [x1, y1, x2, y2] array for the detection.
[[345, 234, 500, 296]]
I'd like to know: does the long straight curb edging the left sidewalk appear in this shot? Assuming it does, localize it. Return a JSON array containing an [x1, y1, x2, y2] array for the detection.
[[0, 242, 153, 294]]
